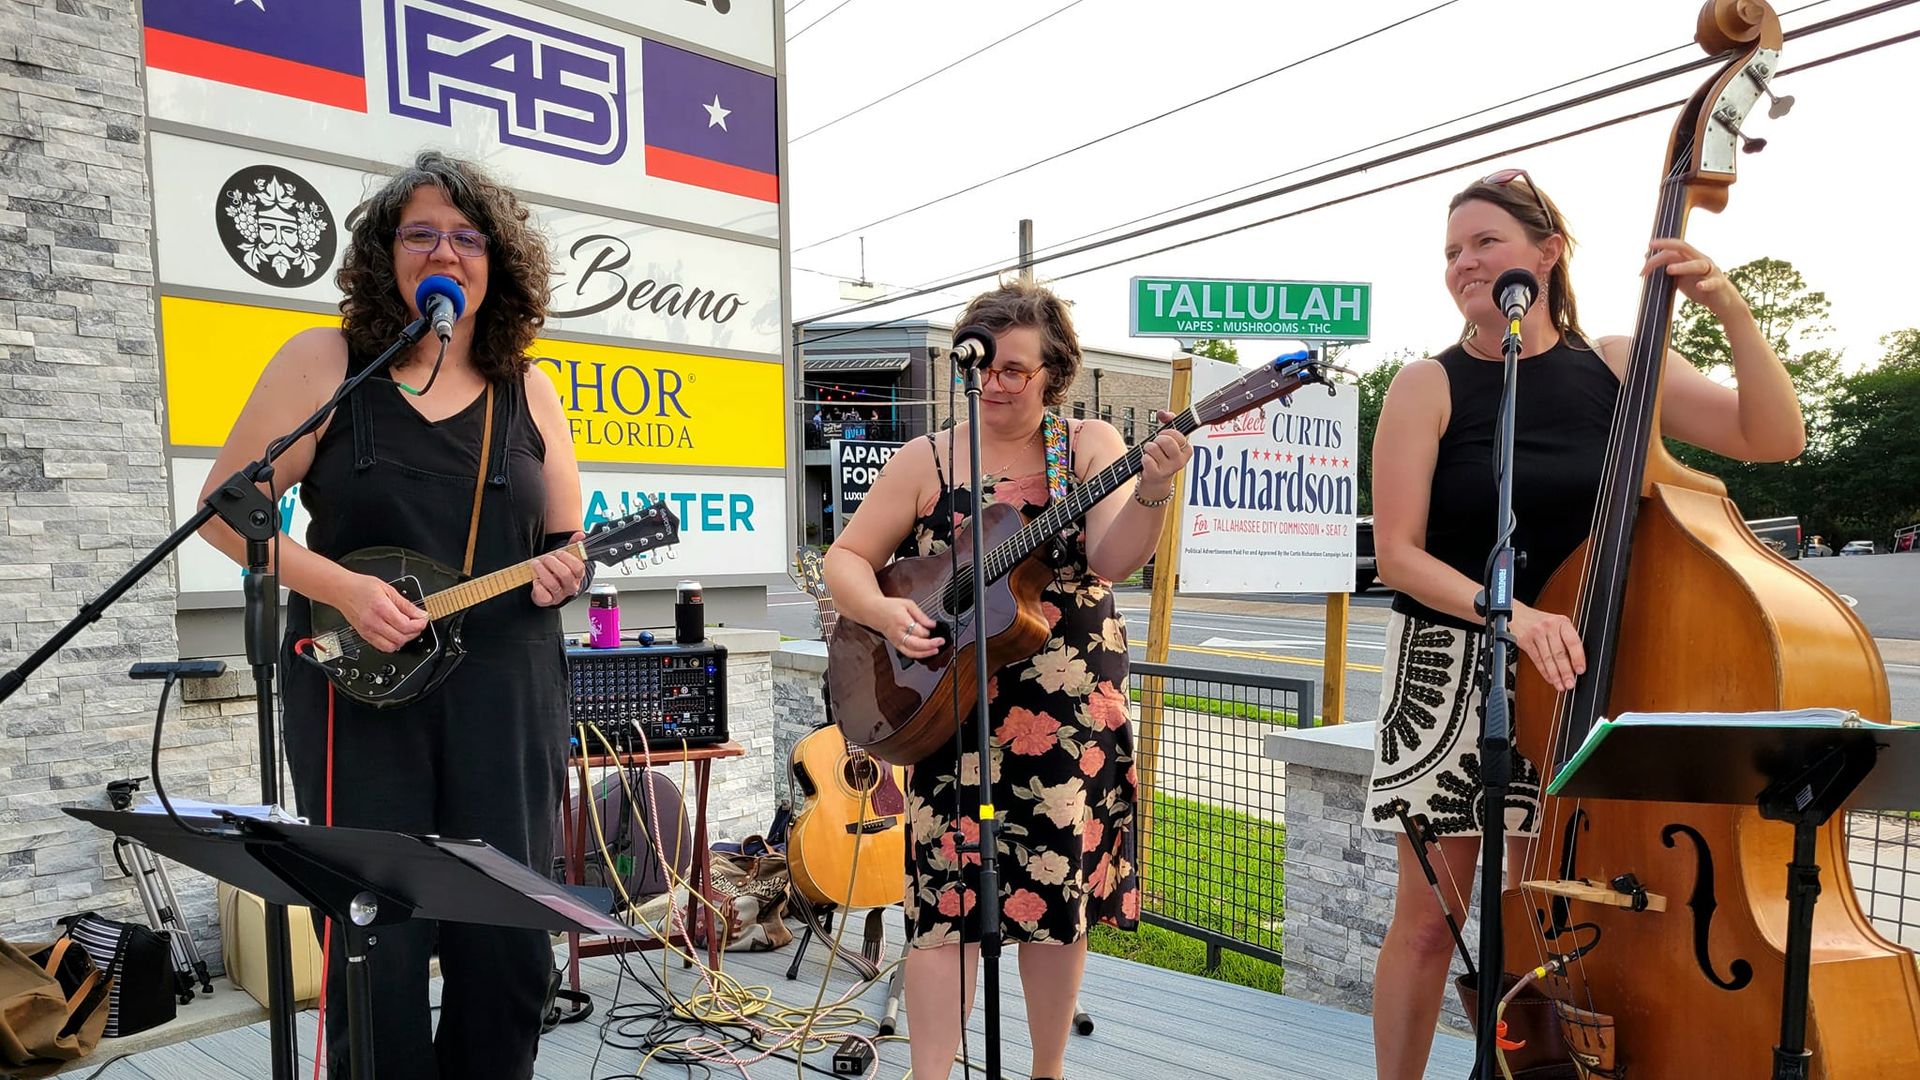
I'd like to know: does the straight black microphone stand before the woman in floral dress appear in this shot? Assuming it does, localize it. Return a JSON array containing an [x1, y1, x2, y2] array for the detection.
[[956, 354, 1000, 1080]]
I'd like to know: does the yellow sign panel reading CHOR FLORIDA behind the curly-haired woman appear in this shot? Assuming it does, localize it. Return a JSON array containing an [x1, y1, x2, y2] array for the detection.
[[159, 296, 787, 469]]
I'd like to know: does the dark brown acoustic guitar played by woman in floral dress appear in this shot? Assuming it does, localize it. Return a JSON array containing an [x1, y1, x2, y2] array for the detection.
[[828, 354, 1332, 765]]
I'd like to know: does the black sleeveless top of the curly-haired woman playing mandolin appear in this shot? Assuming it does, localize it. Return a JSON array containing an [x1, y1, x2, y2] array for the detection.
[[288, 356, 561, 642]]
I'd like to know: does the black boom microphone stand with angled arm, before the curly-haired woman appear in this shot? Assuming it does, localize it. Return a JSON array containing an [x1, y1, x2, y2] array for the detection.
[[0, 317, 430, 1080]]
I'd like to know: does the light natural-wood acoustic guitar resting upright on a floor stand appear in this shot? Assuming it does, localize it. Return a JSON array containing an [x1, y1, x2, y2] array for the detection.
[[787, 552, 906, 909]]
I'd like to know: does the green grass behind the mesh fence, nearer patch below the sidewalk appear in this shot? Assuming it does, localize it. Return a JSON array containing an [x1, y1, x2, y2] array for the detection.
[[1089, 796, 1286, 994]]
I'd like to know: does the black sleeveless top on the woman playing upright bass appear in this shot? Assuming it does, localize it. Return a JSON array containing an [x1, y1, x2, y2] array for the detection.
[[1394, 338, 1620, 630]]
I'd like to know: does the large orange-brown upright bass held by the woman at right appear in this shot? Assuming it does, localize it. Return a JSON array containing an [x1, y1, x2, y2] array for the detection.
[[1501, 0, 1920, 1080]]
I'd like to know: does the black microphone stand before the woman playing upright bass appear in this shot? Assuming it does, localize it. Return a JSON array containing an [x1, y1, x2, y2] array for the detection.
[[1473, 305, 1523, 1080]]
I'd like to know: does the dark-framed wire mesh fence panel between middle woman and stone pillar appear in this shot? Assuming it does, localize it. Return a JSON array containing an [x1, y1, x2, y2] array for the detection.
[[1133, 663, 1315, 967]]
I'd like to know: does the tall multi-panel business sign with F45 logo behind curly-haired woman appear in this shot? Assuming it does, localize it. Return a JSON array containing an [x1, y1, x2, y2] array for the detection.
[[142, 0, 787, 594]]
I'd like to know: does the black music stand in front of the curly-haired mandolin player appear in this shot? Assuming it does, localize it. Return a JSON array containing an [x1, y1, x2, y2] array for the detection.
[[65, 807, 641, 1080]]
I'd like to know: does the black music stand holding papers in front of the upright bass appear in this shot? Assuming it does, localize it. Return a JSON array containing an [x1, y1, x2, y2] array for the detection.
[[1548, 709, 1920, 1080]]
